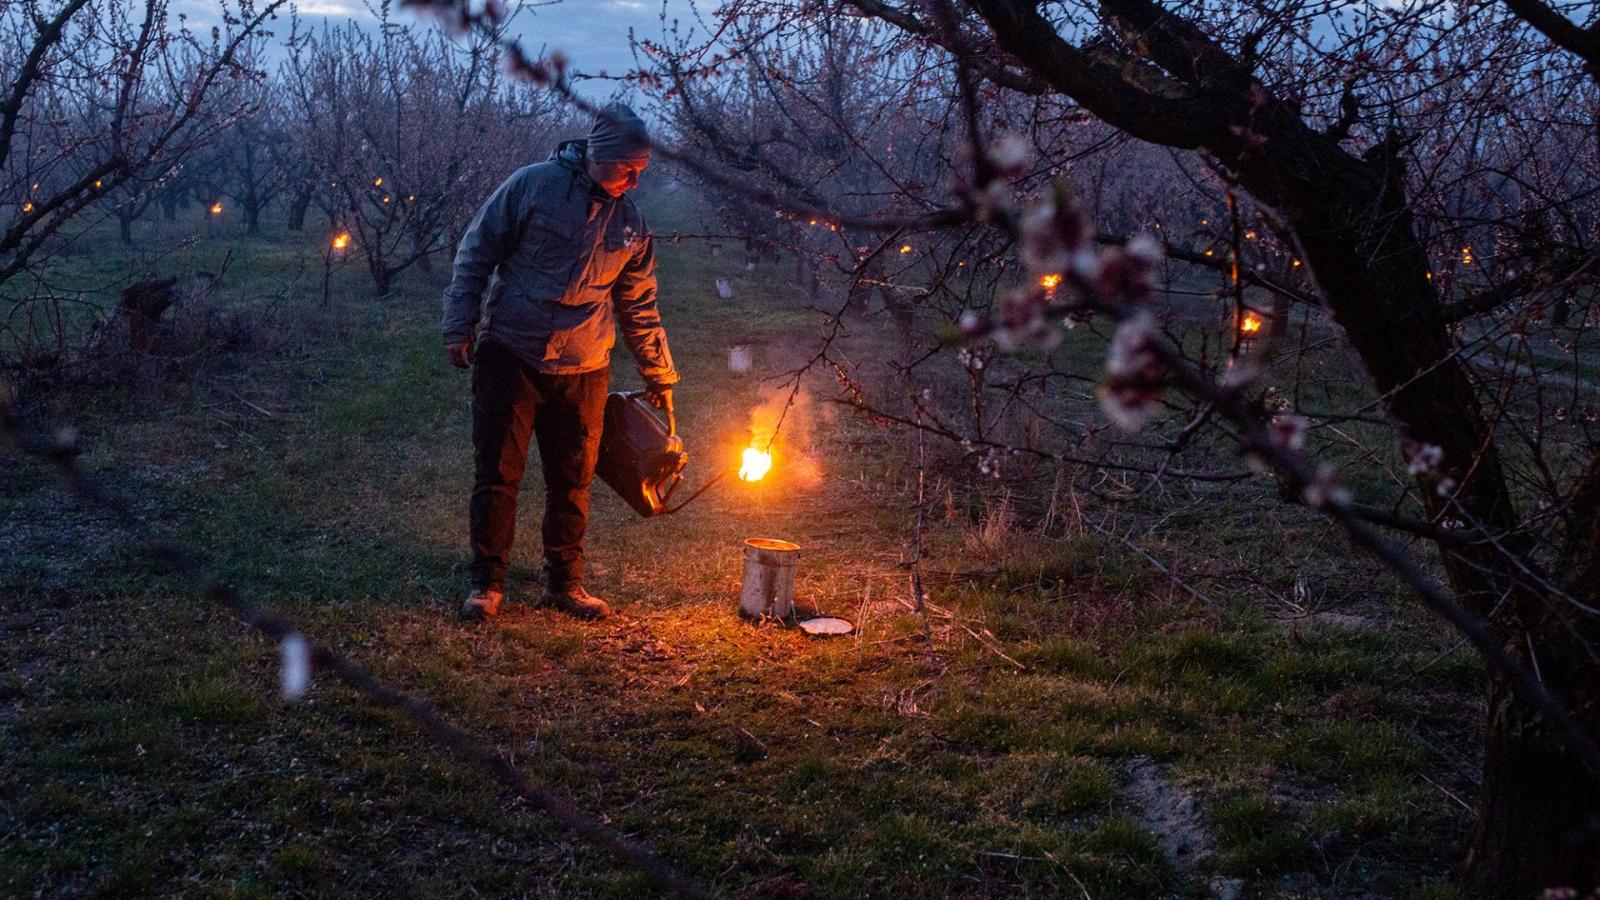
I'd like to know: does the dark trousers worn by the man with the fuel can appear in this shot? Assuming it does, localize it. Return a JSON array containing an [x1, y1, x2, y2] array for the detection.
[[469, 343, 611, 591]]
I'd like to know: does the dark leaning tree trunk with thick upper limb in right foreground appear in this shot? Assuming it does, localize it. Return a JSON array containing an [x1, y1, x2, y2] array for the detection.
[[973, 0, 1600, 897]]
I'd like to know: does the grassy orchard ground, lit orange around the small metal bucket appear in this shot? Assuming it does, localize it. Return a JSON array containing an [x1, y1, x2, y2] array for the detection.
[[0, 185, 1480, 898]]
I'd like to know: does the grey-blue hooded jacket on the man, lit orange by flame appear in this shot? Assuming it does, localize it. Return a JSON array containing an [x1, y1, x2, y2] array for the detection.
[[442, 141, 678, 386]]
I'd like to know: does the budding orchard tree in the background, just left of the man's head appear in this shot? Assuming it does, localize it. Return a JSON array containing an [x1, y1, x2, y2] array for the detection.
[[282, 3, 566, 295]]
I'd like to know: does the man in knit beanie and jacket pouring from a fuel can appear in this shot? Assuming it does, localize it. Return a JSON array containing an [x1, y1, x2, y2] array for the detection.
[[443, 102, 678, 620]]
